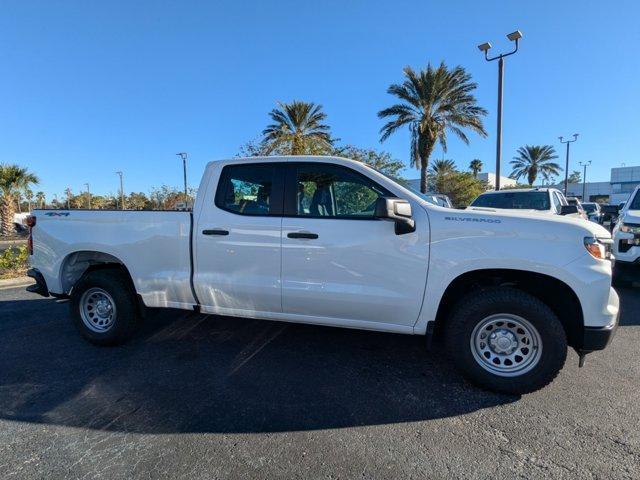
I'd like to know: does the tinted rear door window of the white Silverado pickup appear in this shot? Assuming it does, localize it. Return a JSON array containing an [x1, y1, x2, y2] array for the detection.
[[215, 163, 282, 215]]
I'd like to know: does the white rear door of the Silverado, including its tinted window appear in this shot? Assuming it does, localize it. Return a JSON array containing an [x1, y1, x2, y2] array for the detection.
[[194, 163, 283, 318]]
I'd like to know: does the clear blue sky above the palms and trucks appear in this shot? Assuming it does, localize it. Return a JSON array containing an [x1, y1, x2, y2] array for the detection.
[[0, 0, 640, 198]]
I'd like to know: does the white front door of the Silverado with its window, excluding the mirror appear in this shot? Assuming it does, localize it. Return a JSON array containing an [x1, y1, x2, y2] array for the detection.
[[282, 162, 429, 329]]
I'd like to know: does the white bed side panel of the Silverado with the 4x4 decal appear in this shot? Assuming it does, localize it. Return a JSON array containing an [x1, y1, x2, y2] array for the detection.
[[33, 210, 196, 308]]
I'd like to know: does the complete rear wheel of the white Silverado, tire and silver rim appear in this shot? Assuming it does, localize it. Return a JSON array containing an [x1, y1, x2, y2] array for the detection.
[[70, 269, 138, 345]]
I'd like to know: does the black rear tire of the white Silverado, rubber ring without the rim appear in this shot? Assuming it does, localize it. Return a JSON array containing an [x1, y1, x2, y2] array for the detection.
[[69, 269, 139, 345]]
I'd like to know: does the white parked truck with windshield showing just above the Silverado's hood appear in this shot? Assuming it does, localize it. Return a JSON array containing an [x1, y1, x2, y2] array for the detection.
[[467, 188, 584, 218]]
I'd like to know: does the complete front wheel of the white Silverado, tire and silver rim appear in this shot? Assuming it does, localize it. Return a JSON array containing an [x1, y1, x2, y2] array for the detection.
[[445, 287, 567, 394]]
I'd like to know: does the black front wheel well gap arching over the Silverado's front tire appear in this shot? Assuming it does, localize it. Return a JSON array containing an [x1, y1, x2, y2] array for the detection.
[[432, 269, 584, 348]]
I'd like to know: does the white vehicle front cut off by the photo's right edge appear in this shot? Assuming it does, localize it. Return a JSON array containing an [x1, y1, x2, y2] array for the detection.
[[613, 185, 640, 266]]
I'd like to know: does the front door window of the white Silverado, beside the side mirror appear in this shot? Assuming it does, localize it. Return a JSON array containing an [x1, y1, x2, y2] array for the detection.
[[293, 163, 391, 218]]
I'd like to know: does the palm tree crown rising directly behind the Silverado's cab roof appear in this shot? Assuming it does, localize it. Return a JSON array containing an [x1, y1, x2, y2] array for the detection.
[[262, 100, 333, 155]]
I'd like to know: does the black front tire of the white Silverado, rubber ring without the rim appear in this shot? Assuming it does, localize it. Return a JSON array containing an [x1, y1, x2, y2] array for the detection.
[[445, 287, 567, 395]]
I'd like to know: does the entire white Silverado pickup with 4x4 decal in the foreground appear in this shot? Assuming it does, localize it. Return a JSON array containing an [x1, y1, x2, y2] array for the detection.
[[29, 157, 619, 394]]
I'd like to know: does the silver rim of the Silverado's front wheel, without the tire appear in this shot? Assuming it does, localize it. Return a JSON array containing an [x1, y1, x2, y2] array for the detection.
[[470, 313, 542, 377]]
